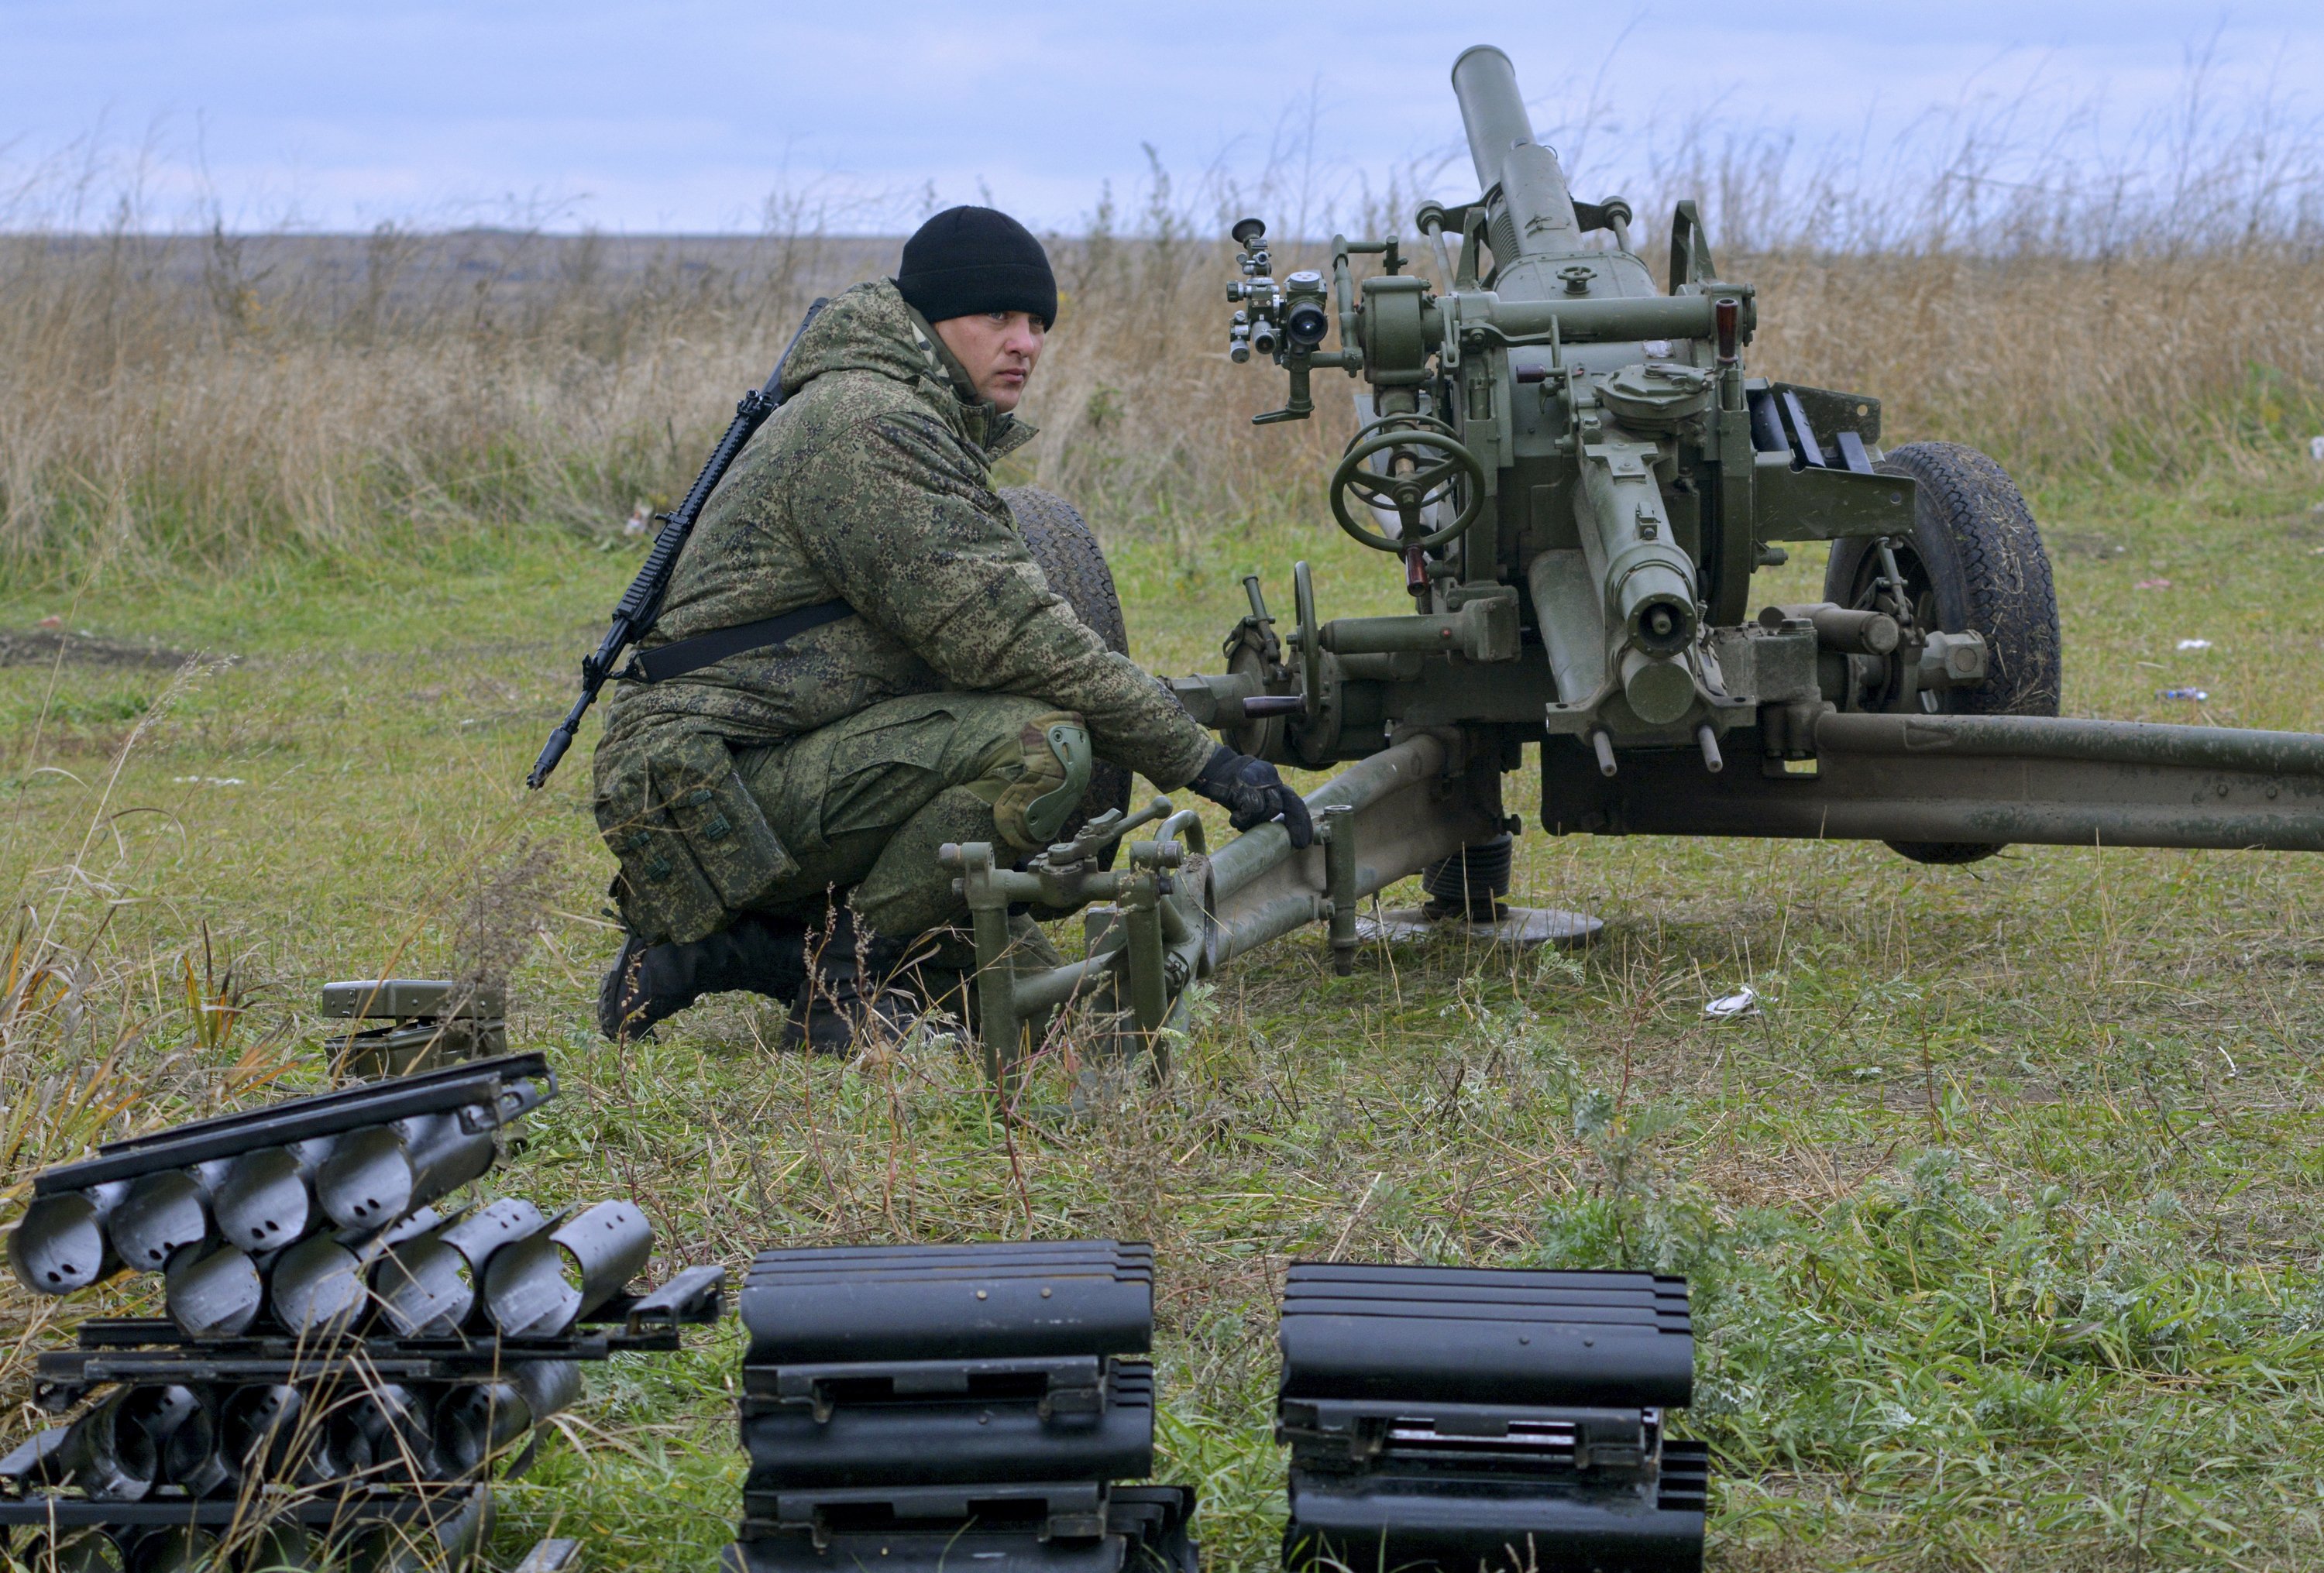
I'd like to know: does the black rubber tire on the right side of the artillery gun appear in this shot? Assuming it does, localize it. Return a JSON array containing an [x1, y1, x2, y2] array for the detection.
[[1824, 441, 2064, 864]]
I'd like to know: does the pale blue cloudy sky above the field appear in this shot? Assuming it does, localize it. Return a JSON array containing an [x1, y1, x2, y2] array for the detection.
[[0, 0, 2324, 232]]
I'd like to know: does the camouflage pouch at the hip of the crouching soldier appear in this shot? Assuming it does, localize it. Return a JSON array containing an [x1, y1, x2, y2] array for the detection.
[[597, 732, 799, 943]]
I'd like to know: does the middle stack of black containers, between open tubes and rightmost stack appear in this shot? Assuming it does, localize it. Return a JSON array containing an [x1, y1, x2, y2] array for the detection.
[[725, 1241, 1195, 1573]]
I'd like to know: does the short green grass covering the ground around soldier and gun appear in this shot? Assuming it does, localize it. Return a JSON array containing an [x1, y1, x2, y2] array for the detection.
[[0, 472, 2324, 1568]]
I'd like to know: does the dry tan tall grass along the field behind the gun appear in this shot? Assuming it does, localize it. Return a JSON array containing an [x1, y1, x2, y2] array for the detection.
[[0, 158, 2324, 583]]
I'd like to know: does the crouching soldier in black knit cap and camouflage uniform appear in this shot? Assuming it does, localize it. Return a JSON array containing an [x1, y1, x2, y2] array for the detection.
[[595, 207, 1311, 1050]]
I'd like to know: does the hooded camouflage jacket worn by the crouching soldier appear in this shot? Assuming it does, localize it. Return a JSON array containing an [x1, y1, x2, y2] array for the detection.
[[595, 279, 1215, 797]]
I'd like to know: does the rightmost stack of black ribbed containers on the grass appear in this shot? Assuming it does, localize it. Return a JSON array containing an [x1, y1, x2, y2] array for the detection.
[[1276, 1262, 1708, 1573]]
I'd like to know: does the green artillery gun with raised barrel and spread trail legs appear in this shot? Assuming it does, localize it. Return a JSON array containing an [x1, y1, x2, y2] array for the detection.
[[946, 46, 2324, 1076]]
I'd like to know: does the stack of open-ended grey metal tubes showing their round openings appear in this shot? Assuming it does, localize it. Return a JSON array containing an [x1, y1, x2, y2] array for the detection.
[[0, 1055, 723, 1573]]
